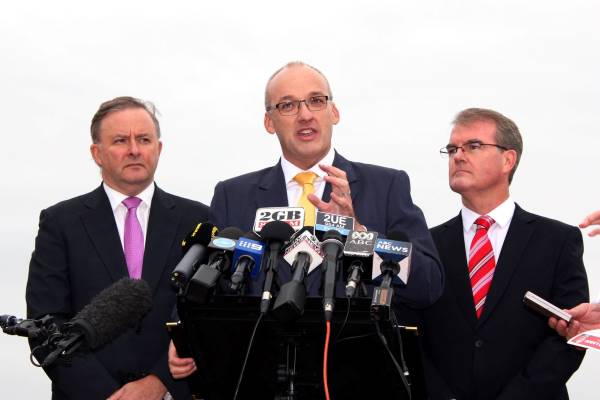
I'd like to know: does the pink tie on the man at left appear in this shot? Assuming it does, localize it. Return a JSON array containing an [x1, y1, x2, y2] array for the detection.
[[123, 197, 144, 279]]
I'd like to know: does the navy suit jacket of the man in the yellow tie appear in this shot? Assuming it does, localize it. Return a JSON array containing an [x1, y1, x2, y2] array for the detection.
[[211, 153, 443, 307]]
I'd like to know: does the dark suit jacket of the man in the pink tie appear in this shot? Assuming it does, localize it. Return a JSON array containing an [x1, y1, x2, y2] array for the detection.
[[26, 186, 209, 399]]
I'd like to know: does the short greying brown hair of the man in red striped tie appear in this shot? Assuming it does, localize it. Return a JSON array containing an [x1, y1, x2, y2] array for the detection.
[[452, 108, 523, 183]]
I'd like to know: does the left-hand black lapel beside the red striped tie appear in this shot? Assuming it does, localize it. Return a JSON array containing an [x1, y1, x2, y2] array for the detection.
[[440, 214, 477, 327]]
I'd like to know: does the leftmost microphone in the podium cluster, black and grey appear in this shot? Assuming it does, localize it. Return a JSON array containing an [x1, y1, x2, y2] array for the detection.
[[171, 223, 219, 294]]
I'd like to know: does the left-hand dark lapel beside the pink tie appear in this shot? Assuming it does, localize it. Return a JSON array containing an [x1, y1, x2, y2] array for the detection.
[[81, 186, 129, 281]]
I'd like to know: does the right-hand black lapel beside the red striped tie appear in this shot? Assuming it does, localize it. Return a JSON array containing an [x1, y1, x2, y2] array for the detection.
[[479, 205, 535, 324]]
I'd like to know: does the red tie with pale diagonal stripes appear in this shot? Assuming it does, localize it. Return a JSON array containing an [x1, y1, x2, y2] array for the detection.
[[469, 215, 496, 318]]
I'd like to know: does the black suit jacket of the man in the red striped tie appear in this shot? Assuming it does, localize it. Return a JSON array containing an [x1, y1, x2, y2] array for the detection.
[[423, 206, 588, 400]]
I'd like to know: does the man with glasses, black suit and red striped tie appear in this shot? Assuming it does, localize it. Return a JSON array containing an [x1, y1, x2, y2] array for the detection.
[[423, 108, 588, 400]]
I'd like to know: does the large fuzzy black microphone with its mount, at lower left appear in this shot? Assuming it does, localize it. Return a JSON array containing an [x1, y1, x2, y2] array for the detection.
[[38, 278, 152, 367]]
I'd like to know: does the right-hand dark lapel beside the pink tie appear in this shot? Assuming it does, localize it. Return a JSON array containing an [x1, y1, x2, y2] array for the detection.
[[142, 187, 181, 292]]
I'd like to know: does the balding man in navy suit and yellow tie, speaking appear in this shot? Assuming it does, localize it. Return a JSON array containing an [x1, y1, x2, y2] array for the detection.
[[170, 62, 443, 377]]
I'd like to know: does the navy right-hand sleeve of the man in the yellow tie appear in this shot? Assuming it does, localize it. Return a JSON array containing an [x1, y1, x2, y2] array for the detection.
[[386, 171, 444, 308]]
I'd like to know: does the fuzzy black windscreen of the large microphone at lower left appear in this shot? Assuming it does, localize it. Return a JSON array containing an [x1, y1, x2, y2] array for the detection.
[[68, 278, 152, 350]]
